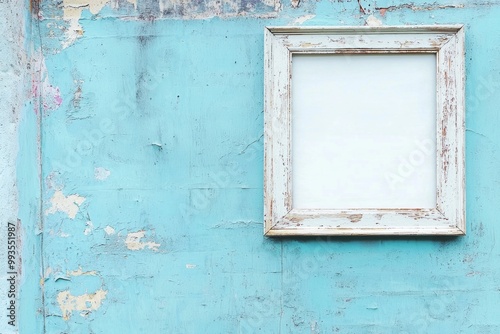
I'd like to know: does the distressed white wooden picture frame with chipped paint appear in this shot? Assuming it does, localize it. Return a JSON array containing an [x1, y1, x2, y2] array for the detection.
[[264, 25, 466, 236]]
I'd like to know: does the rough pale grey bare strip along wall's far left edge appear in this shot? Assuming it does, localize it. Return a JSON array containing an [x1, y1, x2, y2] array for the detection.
[[0, 1, 26, 333]]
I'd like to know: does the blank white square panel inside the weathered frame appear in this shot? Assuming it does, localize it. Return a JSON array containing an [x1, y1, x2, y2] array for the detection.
[[292, 54, 436, 209]]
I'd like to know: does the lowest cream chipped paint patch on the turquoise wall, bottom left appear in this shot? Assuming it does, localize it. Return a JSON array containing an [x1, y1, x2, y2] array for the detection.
[[57, 289, 108, 321]]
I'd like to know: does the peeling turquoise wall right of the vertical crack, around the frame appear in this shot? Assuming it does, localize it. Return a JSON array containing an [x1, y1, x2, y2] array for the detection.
[[11, 0, 500, 334]]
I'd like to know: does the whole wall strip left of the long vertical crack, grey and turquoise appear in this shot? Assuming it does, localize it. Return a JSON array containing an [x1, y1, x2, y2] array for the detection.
[[0, 0, 43, 334]]
